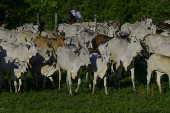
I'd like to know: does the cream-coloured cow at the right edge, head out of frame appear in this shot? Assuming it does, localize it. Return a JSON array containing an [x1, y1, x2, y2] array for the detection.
[[147, 53, 170, 94]]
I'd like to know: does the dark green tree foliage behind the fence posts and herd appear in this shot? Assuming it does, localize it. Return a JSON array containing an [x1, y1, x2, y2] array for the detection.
[[0, 0, 170, 29]]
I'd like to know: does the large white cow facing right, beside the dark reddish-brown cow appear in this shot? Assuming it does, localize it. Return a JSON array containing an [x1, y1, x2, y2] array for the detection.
[[101, 37, 143, 91]]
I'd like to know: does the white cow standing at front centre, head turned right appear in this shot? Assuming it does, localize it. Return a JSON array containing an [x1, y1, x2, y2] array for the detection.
[[57, 42, 90, 95]]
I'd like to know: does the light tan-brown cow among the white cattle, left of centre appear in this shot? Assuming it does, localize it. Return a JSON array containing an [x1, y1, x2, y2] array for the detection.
[[33, 35, 65, 54]]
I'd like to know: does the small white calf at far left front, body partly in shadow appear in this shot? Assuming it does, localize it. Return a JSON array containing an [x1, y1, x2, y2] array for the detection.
[[0, 57, 28, 93]]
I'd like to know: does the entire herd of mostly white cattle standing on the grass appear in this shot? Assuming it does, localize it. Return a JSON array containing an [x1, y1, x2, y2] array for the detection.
[[0, 18, 170, 95]]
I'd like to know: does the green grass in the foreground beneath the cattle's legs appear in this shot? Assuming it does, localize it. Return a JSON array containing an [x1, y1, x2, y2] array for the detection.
[[0, 60, 170, 113]]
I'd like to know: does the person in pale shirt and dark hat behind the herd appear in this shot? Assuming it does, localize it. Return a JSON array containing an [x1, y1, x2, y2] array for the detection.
[[71, 6, 84, 22]]
